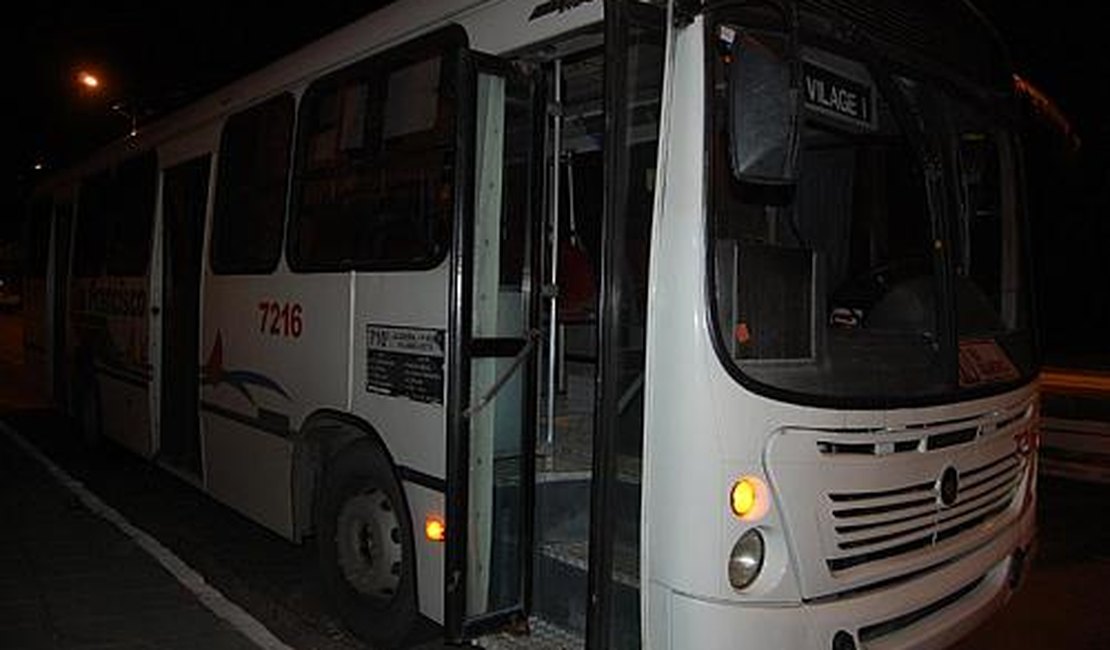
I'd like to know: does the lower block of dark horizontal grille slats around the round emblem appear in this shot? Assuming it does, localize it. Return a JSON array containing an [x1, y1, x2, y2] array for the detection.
[[826, 453, 1025, 572]]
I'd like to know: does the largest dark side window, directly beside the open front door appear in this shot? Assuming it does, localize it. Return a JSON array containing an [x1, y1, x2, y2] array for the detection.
[[289, 31, 455, 271]]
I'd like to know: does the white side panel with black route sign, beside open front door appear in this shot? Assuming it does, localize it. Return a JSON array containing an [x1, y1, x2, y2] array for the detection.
[[351, 264, 448, 621]]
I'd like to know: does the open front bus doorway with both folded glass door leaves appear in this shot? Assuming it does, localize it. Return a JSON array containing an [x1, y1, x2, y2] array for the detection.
[[445, 0, 665, 649]]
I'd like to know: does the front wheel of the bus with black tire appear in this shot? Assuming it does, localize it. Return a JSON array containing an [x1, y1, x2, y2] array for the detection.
[[316, 440, 418, 648]]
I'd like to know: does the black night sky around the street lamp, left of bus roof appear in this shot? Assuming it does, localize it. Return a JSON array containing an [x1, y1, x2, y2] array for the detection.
[[4, 0, 383, 195]]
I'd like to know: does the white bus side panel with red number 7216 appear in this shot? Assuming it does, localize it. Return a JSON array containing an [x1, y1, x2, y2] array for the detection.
[[201, 271, 351, 538]]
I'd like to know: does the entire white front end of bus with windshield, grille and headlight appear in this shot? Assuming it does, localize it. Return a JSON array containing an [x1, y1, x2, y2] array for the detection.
[[643, 0, 1039, 650]]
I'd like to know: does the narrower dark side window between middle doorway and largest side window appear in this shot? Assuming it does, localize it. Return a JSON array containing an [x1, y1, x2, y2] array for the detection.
[[212, 93, 293, 274]]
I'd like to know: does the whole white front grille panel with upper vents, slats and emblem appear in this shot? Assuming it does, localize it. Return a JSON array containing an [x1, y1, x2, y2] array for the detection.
[[764, 392, 1037, 599]]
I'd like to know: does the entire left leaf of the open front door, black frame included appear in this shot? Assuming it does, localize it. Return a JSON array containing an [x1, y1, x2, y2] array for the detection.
[[445, 52, 542, 640]]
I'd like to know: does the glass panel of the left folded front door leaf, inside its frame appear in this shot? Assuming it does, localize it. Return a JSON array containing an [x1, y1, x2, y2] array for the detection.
[[456, 60, 537, 633]]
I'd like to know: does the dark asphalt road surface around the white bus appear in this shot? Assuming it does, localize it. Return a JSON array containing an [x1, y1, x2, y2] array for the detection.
[[0, 310, 1110, 650]]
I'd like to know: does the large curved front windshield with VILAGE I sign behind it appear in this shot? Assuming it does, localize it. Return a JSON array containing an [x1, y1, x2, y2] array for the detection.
[[709, 26, 1033, 404]]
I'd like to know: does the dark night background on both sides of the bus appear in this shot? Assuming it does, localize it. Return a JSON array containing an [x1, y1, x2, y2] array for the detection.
[[0, 0, 1110, 367]]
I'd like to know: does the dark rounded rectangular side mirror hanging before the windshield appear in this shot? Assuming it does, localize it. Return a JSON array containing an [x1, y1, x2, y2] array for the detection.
[[728, 30, 798, 185]]
